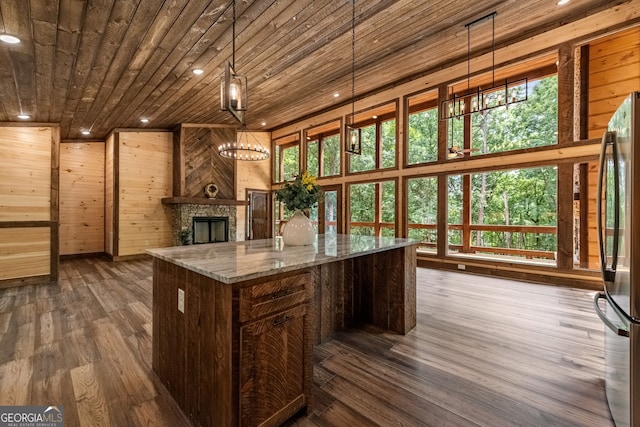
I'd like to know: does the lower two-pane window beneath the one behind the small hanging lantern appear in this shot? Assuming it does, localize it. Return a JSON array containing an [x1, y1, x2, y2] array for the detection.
[[348, 181, 396, 236]]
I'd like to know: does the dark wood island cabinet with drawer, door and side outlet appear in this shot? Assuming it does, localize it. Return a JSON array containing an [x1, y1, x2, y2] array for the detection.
[[153, 259, 314, 426]]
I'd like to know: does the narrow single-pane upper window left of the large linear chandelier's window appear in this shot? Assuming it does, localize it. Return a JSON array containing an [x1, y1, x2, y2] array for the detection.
[[406, 91, 438, 165]]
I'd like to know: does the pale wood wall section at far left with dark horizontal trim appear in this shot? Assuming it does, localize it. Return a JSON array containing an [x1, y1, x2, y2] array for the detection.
[[0, 126, 59, 286]]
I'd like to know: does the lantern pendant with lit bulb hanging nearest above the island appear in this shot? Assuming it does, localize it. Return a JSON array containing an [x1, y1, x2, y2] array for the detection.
[[220, 0, 247, 124]]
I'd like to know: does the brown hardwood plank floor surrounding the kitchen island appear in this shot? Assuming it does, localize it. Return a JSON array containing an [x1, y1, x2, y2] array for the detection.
[[0, 259, 613, 427]]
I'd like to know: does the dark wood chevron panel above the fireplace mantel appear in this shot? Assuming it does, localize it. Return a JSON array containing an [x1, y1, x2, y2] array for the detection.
[[181, 127, 236, 199]]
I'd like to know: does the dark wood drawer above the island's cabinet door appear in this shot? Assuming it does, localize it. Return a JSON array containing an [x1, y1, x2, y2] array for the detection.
[[240, 273, 313, 322]]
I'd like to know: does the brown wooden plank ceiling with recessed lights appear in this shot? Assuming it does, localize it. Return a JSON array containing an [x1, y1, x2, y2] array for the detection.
[[0, 0, 628, 139]]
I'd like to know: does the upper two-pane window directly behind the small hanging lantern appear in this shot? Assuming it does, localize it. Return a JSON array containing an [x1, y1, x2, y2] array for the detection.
[[347, 102, 397, 173]]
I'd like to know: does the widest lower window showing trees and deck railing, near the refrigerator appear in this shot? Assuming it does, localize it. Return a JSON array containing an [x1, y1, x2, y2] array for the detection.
[[448, 166, 558, 263]]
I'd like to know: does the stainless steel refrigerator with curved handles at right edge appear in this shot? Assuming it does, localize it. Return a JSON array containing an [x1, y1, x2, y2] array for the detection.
[[594, 92, 640, 427]]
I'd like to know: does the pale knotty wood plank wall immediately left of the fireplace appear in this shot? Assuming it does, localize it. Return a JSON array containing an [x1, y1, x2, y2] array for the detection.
[[113, 132, 173, 257]]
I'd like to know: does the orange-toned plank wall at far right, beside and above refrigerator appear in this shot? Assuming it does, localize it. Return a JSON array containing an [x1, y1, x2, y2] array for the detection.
[[588, 27, 640, 269]]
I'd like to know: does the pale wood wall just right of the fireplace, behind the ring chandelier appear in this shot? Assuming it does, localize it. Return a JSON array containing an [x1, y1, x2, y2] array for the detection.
[[236, 132, 271, 240]]
